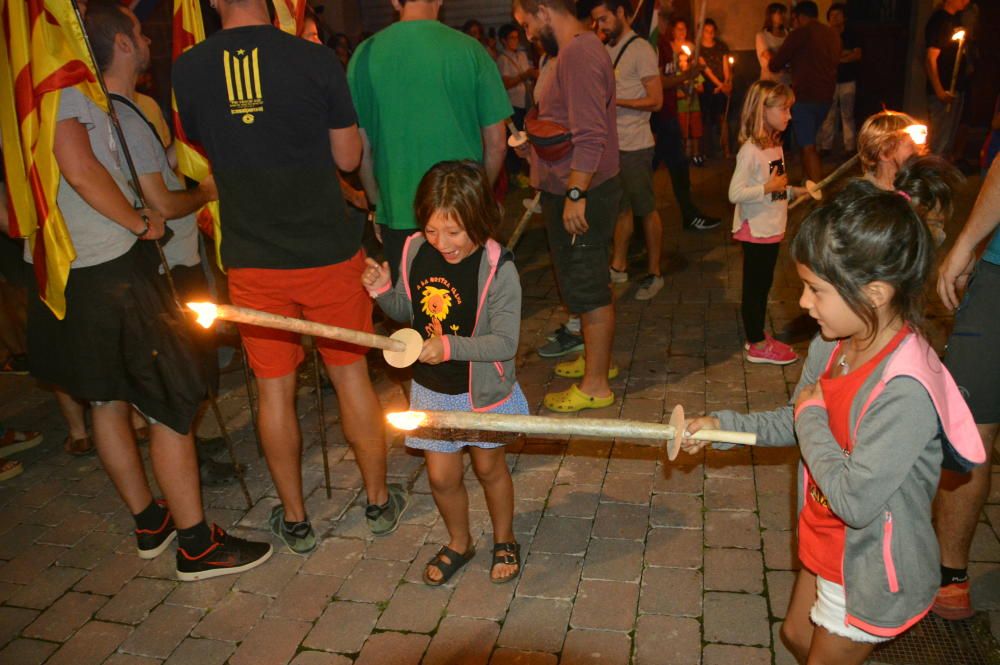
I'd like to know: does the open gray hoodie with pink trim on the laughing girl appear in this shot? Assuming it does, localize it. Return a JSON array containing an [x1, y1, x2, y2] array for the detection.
[[376, 232, 521, 411]]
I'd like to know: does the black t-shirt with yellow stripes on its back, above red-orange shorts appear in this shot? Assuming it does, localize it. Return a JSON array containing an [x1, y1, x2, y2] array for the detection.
[[173, 25, 364, 268]]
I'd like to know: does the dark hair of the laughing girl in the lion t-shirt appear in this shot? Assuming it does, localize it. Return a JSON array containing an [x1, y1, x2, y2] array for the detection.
[[413, 159, 501, 245]]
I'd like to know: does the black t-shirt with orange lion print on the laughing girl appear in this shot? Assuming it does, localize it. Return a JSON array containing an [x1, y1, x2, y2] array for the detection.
[[410, 243, 483, 395]]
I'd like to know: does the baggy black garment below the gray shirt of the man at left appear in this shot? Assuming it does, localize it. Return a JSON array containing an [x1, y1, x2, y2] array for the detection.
[[28, 241, 206, 434]]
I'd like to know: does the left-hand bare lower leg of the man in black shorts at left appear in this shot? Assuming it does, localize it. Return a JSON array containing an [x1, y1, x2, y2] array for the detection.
[[93, 402, 153, 512]]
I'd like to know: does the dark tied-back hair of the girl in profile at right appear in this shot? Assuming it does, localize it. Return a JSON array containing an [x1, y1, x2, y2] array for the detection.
[[791, 178, 934, 334]]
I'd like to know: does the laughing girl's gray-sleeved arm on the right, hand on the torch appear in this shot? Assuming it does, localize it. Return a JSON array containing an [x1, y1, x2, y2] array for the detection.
[[441, 261, 521, 362]]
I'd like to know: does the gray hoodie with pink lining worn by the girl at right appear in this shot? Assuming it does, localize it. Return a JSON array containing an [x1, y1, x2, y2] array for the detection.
[[712, 335, 981, 636]]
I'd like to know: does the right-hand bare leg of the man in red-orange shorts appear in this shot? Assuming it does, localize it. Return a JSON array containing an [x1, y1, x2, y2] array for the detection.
[[326, 358, 389, 506]]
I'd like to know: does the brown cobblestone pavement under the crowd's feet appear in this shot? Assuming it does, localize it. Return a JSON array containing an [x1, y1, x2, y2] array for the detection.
[[0, 158, 1000, 665]]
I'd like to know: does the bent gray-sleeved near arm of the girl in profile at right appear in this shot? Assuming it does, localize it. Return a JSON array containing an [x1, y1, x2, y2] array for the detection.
[[795, 376, 940, 528]]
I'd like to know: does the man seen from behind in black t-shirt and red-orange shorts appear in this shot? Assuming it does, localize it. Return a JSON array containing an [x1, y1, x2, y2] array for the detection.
[[173, 0, 407, 554]]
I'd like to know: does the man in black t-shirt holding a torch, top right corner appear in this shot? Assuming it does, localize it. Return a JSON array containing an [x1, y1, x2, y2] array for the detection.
[[924, 0, 969, 155]]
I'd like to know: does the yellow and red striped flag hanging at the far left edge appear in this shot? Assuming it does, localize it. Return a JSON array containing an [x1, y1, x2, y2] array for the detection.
[[0, 0, 107, 319]]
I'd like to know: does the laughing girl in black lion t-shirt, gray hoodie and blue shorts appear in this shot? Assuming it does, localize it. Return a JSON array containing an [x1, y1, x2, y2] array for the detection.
[[362, 161, 528, 586]]
